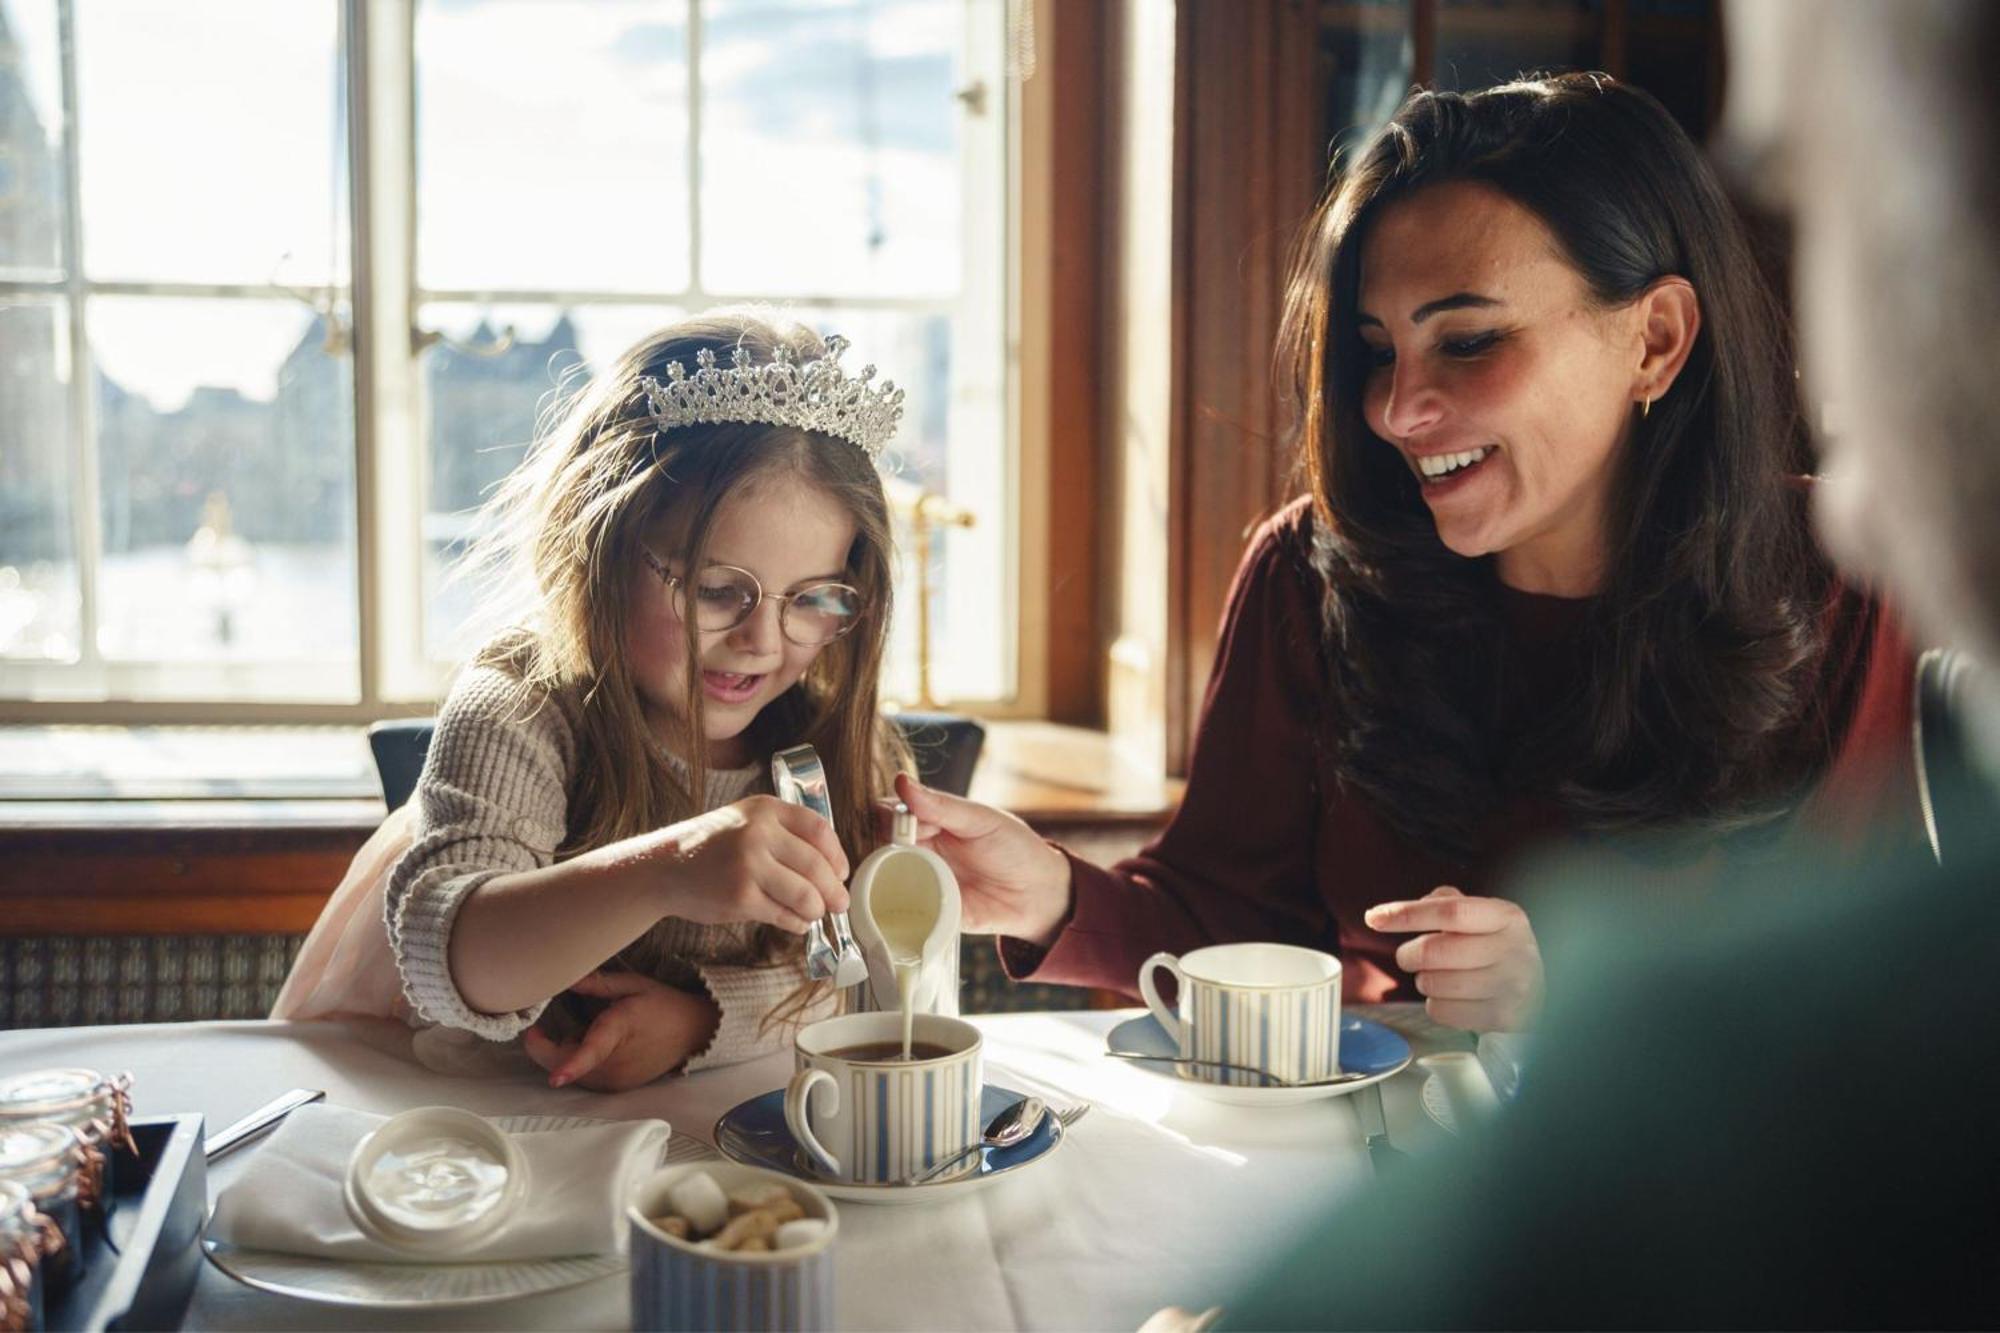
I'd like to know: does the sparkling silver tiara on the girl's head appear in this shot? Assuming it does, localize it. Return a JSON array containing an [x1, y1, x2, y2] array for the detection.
[[640, 334, 902, 460]]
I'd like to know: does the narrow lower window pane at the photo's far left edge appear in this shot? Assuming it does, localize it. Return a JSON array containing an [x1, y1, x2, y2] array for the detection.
[[0, 298, 80, 660]]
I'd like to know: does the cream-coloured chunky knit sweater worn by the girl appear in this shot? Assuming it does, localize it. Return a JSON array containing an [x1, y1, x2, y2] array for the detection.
[[386, 667, 834, 1073]]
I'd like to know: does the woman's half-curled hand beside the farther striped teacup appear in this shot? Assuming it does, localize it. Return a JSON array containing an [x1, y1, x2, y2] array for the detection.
[[1364, 887, 1542, 1033]]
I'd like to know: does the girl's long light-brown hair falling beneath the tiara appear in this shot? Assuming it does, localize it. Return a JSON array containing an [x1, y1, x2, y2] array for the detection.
[[460, 310, 910, 1023]]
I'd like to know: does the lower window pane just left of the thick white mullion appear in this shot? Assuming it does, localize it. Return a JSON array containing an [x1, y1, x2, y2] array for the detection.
[[88, 296, 358, 697]]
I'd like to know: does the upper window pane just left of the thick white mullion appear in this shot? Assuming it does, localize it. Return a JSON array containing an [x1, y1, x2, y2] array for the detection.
[[76, 0, 348, 284]]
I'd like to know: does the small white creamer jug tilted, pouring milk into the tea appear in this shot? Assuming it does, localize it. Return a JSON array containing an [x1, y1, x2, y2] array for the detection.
[[848, 803, 960, 1015]]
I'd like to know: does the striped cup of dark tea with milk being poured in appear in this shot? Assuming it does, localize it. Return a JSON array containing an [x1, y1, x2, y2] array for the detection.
[[784, 1013, 984, 1185]]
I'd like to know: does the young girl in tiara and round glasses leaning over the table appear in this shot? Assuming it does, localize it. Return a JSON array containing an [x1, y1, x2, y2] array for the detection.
[[272, 312, 902, 1089]]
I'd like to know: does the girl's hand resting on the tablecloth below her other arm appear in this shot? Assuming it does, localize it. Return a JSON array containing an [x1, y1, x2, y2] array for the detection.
[[522, 973, 722, 1093]]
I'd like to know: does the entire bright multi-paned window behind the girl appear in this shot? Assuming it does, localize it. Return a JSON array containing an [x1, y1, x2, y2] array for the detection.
[[0, 0, 1018, 721]]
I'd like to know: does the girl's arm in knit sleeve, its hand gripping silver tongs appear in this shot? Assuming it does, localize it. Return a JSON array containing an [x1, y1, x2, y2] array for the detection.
[[386, 669, 848, 1041]]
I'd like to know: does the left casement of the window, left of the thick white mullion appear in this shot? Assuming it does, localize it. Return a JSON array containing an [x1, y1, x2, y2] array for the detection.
[[0, 0, 358, 701]]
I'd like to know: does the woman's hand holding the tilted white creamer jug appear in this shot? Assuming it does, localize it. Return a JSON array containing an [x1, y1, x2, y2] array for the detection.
[[896, 773, 1070, 947]]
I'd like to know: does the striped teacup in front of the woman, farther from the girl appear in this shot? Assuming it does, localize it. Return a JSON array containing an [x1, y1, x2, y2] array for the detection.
[[1138, 945, 1340, 1087]]
